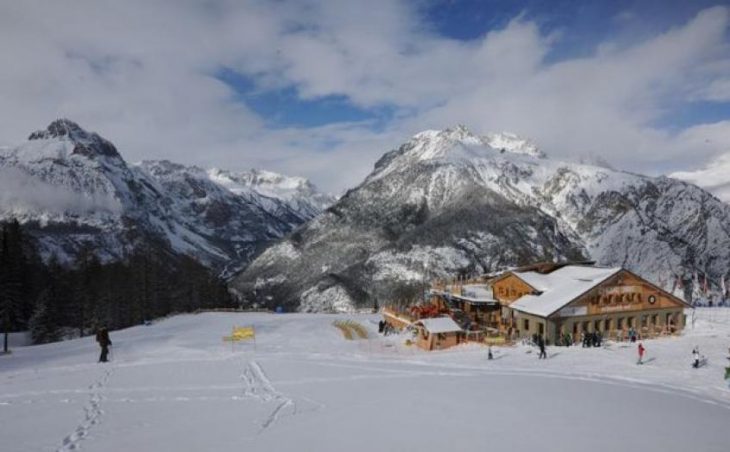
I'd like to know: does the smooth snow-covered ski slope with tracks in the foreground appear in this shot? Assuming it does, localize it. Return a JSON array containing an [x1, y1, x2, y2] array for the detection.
[[0, 309, 730, 452]]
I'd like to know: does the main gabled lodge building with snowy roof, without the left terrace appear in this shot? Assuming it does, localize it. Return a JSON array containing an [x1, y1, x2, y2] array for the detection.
[[490, 265, 689, 343]]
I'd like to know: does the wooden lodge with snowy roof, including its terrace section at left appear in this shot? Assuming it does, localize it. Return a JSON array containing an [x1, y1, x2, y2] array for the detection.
[[396, 263, 690, 349]]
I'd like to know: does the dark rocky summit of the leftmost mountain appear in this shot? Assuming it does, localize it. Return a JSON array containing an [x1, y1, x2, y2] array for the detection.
[[28, 118, 121, 159]]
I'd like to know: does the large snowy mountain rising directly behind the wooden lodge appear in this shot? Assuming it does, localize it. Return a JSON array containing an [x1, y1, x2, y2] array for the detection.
[[234, 126, 730, 311]]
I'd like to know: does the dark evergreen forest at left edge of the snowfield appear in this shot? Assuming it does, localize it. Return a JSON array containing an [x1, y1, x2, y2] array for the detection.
[[0, 221, 234, 351]]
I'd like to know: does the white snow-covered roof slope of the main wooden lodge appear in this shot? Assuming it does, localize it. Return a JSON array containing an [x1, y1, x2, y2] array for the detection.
[[510, 265, 621, 317]]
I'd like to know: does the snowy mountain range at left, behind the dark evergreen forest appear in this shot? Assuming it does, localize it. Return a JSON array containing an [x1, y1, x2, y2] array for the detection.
[[0, 119, 327, 273]]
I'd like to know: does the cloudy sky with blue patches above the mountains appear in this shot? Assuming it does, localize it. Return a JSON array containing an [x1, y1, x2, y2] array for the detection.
[[0, 0, 730, 193]]
